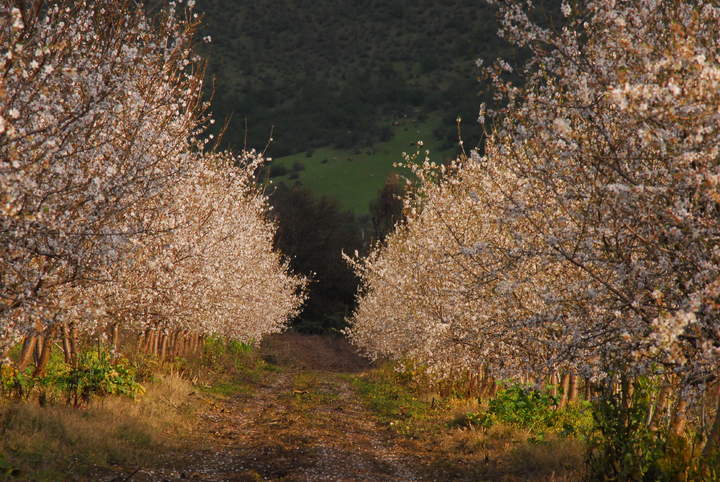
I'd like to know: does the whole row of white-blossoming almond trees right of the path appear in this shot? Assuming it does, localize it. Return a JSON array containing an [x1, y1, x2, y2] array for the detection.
[[352, 0, 720, 456]]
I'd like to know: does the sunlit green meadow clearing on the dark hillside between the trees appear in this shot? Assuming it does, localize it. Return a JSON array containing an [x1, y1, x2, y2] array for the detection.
[[272, 117, 454, 215]]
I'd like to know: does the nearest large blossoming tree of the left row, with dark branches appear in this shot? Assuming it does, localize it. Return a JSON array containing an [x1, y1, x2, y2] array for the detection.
[[0, 1, 207, 358]]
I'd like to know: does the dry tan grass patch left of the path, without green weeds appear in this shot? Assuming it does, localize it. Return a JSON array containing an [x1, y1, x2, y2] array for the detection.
[[0, 376, 204, 480]]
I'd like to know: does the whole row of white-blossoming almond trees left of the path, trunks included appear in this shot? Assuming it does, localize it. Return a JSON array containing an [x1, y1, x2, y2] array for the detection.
[[0, 0, 304, 374]]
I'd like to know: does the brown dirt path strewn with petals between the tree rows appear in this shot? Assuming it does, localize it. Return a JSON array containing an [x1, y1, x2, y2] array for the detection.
[[115, 337, 421, 481]]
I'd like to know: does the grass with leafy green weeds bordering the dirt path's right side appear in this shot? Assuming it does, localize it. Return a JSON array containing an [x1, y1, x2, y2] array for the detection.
[[350, 364, 590, 481]]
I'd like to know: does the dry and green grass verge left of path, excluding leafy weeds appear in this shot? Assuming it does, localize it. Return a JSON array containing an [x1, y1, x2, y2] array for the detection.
[[0, 339, 280, 481]]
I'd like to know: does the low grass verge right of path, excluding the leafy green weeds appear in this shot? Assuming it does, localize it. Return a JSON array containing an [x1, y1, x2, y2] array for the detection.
[[349, 365, 585, 481]]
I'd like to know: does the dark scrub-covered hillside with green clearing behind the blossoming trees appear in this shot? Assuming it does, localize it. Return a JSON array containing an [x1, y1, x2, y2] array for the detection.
[[188, 0, 559, 213]]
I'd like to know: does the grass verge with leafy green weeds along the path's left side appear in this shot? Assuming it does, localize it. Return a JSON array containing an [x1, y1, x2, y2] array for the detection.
[[0, 338, 278, 481]]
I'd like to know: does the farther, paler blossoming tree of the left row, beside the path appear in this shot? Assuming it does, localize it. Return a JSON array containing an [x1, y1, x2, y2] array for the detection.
[[85, 152, 305, 356]]
